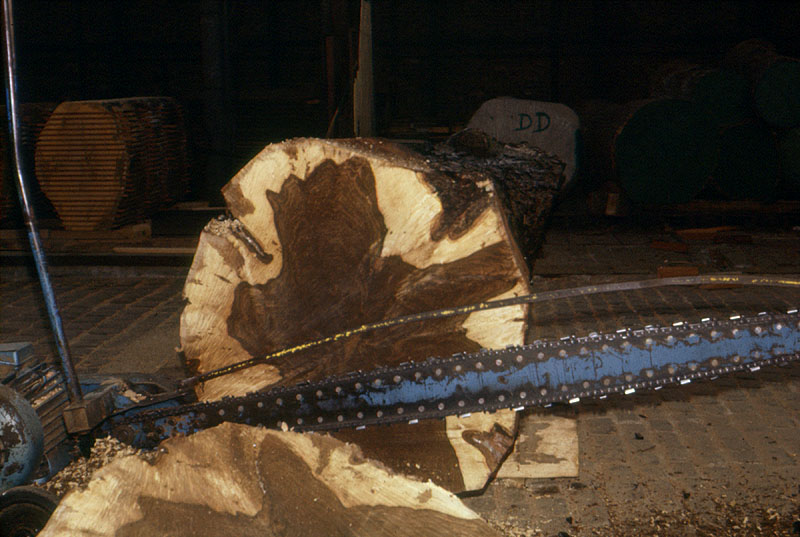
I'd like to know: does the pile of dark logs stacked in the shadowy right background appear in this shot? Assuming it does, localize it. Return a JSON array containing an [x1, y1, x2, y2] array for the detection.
[[581, 39, 800, 205]]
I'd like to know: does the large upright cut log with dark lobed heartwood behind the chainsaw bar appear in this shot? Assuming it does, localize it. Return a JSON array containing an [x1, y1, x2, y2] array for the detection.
[[181, 137, 562, 491]]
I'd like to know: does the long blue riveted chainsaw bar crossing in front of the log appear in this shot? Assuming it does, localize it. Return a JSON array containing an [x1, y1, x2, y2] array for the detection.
[[109, 310, 800, 446]]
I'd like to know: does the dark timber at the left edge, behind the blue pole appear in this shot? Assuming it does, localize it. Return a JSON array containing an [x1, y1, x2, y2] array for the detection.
[[0, 103, 56, 225]]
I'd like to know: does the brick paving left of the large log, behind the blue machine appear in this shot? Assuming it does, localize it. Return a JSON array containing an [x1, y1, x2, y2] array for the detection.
[[0, 268, 185, 375]]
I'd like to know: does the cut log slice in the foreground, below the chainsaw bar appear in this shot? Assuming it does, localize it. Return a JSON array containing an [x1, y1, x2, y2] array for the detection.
[[39, 424, 497, 537]]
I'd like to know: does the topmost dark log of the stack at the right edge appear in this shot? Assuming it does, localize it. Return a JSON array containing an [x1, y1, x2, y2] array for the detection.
[[724, 39, 800, 127]]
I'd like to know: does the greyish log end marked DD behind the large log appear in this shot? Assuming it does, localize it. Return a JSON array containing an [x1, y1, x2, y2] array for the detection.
[[467, 97, 581, 192]]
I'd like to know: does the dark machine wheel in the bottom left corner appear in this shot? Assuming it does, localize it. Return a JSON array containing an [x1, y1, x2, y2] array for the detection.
[[0, 486, 58, 537]]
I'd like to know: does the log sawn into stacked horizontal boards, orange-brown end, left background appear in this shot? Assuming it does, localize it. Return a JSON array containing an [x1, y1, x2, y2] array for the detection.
[[36, 97, 188, 231]]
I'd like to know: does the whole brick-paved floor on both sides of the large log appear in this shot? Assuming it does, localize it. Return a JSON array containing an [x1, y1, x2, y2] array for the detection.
[[0, 207, 800, 537]]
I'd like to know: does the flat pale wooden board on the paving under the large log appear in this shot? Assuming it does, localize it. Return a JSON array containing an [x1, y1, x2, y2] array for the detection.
[[497, 414, 578, 479]]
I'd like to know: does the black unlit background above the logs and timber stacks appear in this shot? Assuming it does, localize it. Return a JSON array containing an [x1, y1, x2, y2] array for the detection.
[[15, 0, 800, 198]]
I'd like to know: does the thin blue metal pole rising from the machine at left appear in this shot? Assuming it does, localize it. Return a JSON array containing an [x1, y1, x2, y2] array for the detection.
[[3, 0, 83, 403]]
